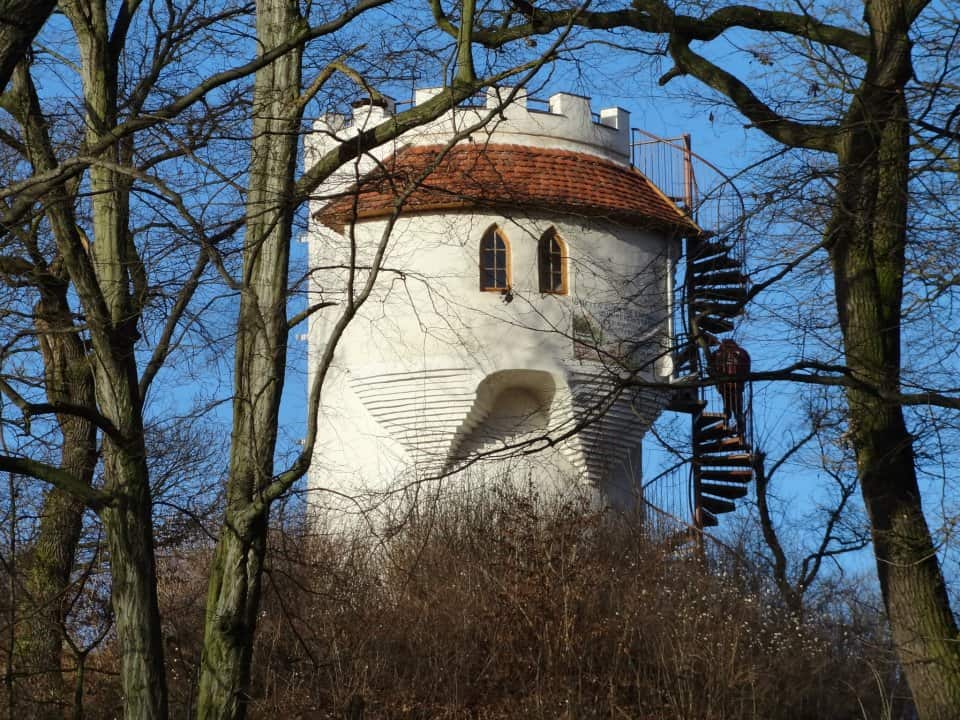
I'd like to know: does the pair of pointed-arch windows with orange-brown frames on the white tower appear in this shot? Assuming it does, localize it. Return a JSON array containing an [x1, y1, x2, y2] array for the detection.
[[480, 225, 567, 295]]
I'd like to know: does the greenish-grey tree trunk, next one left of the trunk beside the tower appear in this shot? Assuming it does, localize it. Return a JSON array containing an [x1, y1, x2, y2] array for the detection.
[[60, 0, 167, 720]]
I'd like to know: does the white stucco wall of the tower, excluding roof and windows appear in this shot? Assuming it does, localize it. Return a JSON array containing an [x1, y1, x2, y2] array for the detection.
[[308, 95, 673, 528]]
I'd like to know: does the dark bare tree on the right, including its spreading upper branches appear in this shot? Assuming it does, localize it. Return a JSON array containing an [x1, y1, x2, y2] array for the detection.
[[428, 0, 960, 719]]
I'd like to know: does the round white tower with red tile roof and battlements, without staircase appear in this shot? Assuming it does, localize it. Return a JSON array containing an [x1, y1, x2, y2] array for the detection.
[[307, 89, 694, 524]]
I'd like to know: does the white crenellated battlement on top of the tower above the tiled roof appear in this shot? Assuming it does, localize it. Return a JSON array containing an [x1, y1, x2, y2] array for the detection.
[[307, 87, 630, 172]]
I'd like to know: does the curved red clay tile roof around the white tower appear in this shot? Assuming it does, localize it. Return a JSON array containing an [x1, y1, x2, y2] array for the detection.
[[317, 143, 696, 231]]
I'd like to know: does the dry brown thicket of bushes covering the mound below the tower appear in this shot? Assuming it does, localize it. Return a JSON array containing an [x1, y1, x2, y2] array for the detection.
[[58, 490, 894, 720]]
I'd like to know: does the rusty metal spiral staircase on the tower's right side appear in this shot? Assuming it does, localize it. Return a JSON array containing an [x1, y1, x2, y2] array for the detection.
[[634, 132, 759, 545]]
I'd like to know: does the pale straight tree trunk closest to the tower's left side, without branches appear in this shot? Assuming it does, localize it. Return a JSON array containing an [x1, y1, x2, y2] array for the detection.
[[197, 0, 302, 720]]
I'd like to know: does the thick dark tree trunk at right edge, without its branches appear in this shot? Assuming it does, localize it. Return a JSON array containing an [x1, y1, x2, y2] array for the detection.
[[827, 9, 960, 708]]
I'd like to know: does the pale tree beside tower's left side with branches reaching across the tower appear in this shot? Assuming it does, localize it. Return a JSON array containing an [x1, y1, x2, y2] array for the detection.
[[197, 0, 512, 720]]
